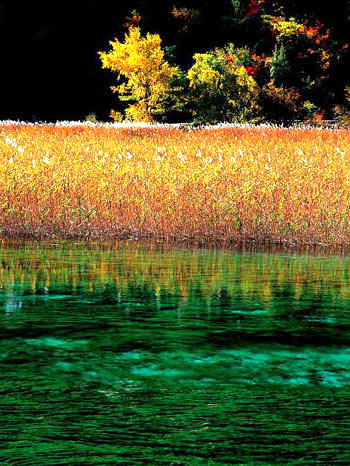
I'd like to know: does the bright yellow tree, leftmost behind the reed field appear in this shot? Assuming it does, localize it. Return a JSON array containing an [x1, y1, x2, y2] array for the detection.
[[98, 27, 178, 122]]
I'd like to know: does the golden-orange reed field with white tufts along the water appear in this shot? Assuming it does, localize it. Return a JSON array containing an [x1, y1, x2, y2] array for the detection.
[[0, 122, 350, 245]]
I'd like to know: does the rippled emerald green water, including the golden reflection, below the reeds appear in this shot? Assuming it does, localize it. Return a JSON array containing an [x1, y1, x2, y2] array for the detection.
[[0, 242, 350, 466]]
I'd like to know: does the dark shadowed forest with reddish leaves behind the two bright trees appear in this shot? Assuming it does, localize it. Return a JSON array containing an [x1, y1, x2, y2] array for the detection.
[[0, 0, 350, 122]]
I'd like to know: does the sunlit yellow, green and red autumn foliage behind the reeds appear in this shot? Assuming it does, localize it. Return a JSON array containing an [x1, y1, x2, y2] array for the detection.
[[100, 0, 349, 124]]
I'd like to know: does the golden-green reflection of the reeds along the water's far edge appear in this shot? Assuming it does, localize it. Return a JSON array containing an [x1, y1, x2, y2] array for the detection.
[[0, 242, 350, 305]]
